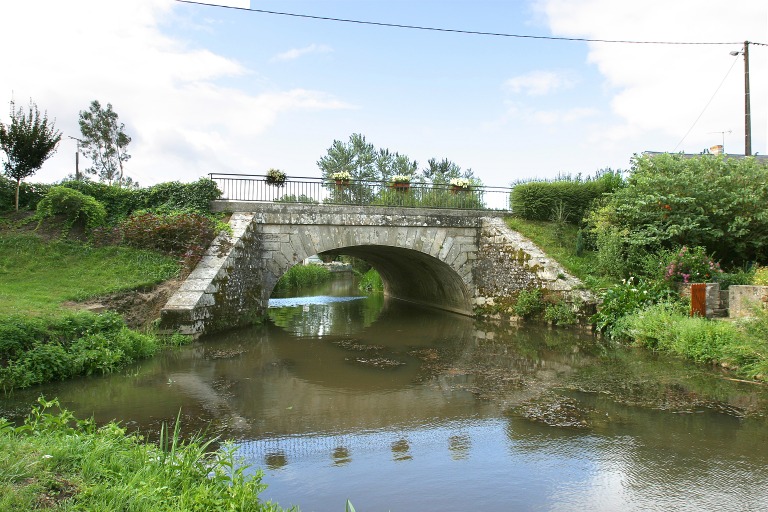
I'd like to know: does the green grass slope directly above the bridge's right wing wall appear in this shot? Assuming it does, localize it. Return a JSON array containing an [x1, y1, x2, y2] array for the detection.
[[505, 217, 616, 290]]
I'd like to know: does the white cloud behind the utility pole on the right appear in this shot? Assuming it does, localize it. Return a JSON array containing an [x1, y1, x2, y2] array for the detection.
[[538, 0, 768, 153]]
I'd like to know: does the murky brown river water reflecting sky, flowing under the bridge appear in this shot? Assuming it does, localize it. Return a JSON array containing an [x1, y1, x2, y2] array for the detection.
[[0, 279, 768, 512]]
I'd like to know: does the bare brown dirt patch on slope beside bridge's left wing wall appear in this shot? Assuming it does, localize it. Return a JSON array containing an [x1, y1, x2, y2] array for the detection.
[[63, 279, 183, 329]]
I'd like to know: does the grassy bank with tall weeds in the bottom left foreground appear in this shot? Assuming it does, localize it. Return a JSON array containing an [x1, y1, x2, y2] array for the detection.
[[0, 400, 290, 512]]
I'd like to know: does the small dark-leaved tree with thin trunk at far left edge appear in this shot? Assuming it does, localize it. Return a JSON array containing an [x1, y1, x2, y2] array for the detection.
[[0, 100, 61, 211]]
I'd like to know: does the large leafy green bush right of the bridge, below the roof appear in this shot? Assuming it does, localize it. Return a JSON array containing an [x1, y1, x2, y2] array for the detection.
[[589, 155, 768, 277]]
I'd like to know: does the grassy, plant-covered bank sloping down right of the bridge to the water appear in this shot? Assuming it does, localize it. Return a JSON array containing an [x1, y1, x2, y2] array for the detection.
[[507, 218, 768, 380]]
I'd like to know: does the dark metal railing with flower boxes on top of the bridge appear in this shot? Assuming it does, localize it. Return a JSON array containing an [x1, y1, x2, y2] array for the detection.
[[210, 173, 511, 211]]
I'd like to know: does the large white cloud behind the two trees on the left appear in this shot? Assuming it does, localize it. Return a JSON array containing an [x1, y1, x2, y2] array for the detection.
[[0, 0, 349, 185]]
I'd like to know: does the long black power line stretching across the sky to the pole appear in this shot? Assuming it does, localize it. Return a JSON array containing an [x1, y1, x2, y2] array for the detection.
[[176, 0, 752, 46]]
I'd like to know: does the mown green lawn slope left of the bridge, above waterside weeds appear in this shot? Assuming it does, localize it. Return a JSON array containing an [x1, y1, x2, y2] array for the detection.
[[0, 234, 179, 316]]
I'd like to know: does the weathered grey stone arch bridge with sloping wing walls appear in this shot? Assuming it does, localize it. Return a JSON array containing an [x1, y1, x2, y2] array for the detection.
[[161, 201, 580, 335]]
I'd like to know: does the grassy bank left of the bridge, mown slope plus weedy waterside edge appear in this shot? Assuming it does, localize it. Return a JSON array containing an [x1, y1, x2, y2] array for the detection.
[[0, 234, 182, 392]]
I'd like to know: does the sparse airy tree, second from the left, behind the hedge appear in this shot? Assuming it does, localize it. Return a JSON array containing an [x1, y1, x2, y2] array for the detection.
[[79, 100, 131, 185]]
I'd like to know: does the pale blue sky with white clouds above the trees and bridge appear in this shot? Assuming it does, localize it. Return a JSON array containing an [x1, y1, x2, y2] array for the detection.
[[0, 0, 768, 186]]
